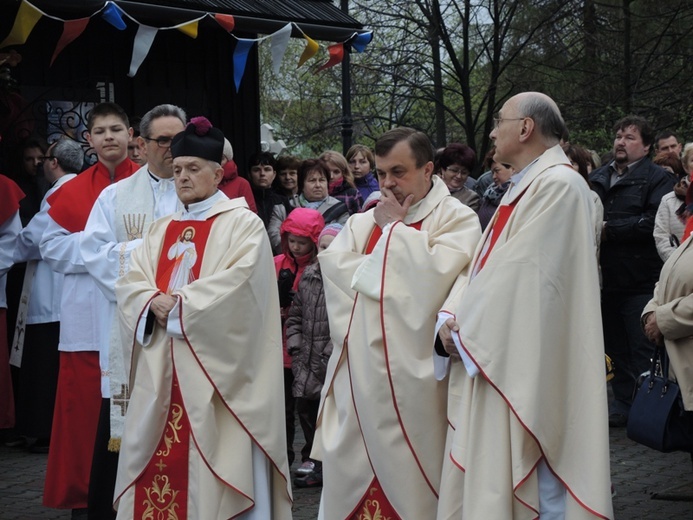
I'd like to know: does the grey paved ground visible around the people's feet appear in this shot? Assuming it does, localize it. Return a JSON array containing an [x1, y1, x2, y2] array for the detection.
[[0, 429, 693, 520]]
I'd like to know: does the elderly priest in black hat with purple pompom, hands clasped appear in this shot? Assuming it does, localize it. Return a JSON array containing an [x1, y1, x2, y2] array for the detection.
[[115, 118, 292, 520]]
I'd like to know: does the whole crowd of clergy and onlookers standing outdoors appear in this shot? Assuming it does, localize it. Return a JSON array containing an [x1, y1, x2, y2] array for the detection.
[[0, 92, 693, 520]]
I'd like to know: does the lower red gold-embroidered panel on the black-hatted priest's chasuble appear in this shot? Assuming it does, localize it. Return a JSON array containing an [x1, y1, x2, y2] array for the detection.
[[133, 370, 190, 520]]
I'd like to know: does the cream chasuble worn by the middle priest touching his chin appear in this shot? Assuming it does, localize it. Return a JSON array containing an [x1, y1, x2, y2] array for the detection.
[[313, 177, 480, 520]]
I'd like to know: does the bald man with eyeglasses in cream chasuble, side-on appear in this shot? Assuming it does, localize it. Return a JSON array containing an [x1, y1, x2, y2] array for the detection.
[[434, 92, 613, 520]]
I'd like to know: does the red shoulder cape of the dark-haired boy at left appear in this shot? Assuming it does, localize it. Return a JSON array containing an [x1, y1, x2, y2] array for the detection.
[[48, 157, 140, 233]]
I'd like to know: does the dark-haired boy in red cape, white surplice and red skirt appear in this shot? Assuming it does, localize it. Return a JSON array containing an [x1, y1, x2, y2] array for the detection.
[[39, 102, 138, 514]]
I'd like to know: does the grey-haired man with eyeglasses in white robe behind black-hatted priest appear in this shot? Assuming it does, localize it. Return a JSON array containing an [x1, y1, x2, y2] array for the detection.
[[80, 104, 187, 520]]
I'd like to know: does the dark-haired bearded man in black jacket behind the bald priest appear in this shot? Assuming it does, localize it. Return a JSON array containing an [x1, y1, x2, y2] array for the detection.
[[590, 116, 675, 426]]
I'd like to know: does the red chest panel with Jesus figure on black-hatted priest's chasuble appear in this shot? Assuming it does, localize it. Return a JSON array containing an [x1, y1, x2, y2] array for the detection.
[[156, 217, 215, 294]]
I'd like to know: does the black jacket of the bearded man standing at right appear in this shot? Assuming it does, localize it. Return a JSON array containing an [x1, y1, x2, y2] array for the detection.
[[590, 157, 676, 294]]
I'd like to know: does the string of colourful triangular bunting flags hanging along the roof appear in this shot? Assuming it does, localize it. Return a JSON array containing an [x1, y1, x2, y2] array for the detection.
[[0, 0, 373, 91]]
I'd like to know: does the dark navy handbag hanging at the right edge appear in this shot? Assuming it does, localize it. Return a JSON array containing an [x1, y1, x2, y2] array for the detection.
[[626, 345, 693, 453]]
